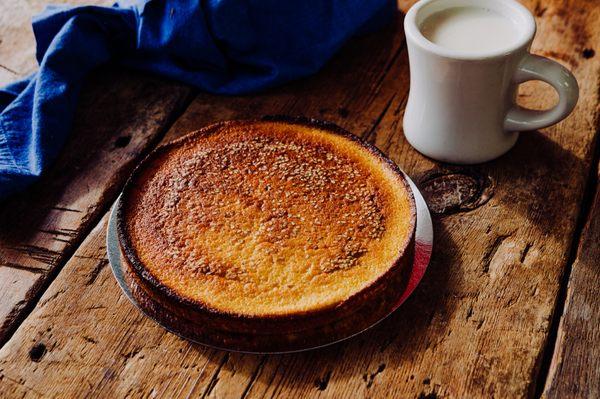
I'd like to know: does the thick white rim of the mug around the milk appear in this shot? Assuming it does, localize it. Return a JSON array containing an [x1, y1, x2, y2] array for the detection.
[[404, 0, 536, 60]]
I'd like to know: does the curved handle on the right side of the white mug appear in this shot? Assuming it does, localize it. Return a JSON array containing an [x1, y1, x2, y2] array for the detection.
[[504, 54, 579, 132]]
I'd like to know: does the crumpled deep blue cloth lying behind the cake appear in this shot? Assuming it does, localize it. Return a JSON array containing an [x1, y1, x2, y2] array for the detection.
[[0, 0, 394, 199]]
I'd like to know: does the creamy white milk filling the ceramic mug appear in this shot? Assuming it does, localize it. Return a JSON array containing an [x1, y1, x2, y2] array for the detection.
[[420, 7, 521, 53]]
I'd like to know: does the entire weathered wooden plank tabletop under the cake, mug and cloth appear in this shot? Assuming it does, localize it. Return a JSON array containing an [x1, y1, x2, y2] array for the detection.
[[0, 0, 600, 398]]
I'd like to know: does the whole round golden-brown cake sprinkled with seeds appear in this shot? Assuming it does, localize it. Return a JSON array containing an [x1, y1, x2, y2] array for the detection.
[[117, 118, 416, 350]]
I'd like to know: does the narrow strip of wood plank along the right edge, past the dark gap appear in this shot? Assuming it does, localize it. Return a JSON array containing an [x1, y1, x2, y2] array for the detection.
[[544, 161, 600, 398]]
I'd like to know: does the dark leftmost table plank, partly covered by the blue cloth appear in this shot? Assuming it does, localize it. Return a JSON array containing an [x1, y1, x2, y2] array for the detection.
[[0, 1, 190, 345]]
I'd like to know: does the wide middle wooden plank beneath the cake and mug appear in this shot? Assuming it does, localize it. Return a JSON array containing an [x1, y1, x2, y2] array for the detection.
[[0, 0, 600, 398]]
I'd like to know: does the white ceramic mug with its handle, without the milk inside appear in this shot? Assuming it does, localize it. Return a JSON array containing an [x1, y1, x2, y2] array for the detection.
[[404, 0, 579, 164]]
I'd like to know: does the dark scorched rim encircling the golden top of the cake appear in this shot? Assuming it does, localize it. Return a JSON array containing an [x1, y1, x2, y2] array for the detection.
[[116, 115, 416, 330]]
